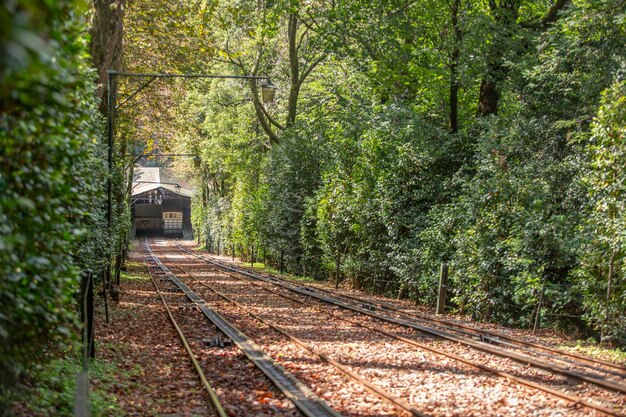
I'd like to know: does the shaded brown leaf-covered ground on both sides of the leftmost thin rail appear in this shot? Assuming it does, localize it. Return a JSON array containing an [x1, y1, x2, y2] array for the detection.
[[95, 244, 296, 416]]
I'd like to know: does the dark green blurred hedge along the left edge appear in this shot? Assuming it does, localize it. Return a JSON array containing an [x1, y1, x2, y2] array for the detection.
[[0, 0, 107, 385]]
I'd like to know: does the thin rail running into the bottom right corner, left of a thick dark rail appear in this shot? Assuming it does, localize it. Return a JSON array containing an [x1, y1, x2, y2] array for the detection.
[[171, 246, 626, 417]]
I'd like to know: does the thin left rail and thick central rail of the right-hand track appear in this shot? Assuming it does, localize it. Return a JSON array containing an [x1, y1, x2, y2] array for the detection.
[[172, 240, 624, 416]]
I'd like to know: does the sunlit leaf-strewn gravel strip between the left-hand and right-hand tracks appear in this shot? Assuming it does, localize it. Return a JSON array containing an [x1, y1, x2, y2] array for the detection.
[[154, 240, 616, 416]]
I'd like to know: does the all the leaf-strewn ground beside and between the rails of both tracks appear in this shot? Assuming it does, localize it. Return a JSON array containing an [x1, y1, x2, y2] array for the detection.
[[98, 241, 626, 416]]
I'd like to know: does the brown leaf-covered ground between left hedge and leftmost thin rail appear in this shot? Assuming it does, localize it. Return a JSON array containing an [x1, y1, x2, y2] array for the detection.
[[94, 253, 210, 415]]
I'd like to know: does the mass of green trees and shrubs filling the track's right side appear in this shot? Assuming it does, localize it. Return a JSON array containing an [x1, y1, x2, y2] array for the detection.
[[126, 0, 626, 343]]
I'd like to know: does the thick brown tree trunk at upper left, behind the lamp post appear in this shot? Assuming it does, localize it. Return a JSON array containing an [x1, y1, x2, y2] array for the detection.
[[90, 0, 126, 116]]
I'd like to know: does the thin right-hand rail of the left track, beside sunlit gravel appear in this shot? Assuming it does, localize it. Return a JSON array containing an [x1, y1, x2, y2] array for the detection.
[[166, 257, 427, 417]]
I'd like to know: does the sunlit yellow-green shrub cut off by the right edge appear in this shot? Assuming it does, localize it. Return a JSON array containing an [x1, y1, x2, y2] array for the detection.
[[579, 80, 626, 343]]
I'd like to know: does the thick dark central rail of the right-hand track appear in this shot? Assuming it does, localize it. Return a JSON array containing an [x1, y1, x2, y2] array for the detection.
[[173, 246, 626, 393]]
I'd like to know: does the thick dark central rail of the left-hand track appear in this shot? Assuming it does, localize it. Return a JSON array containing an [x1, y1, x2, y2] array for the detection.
[[146, 239, 341, 417]]
